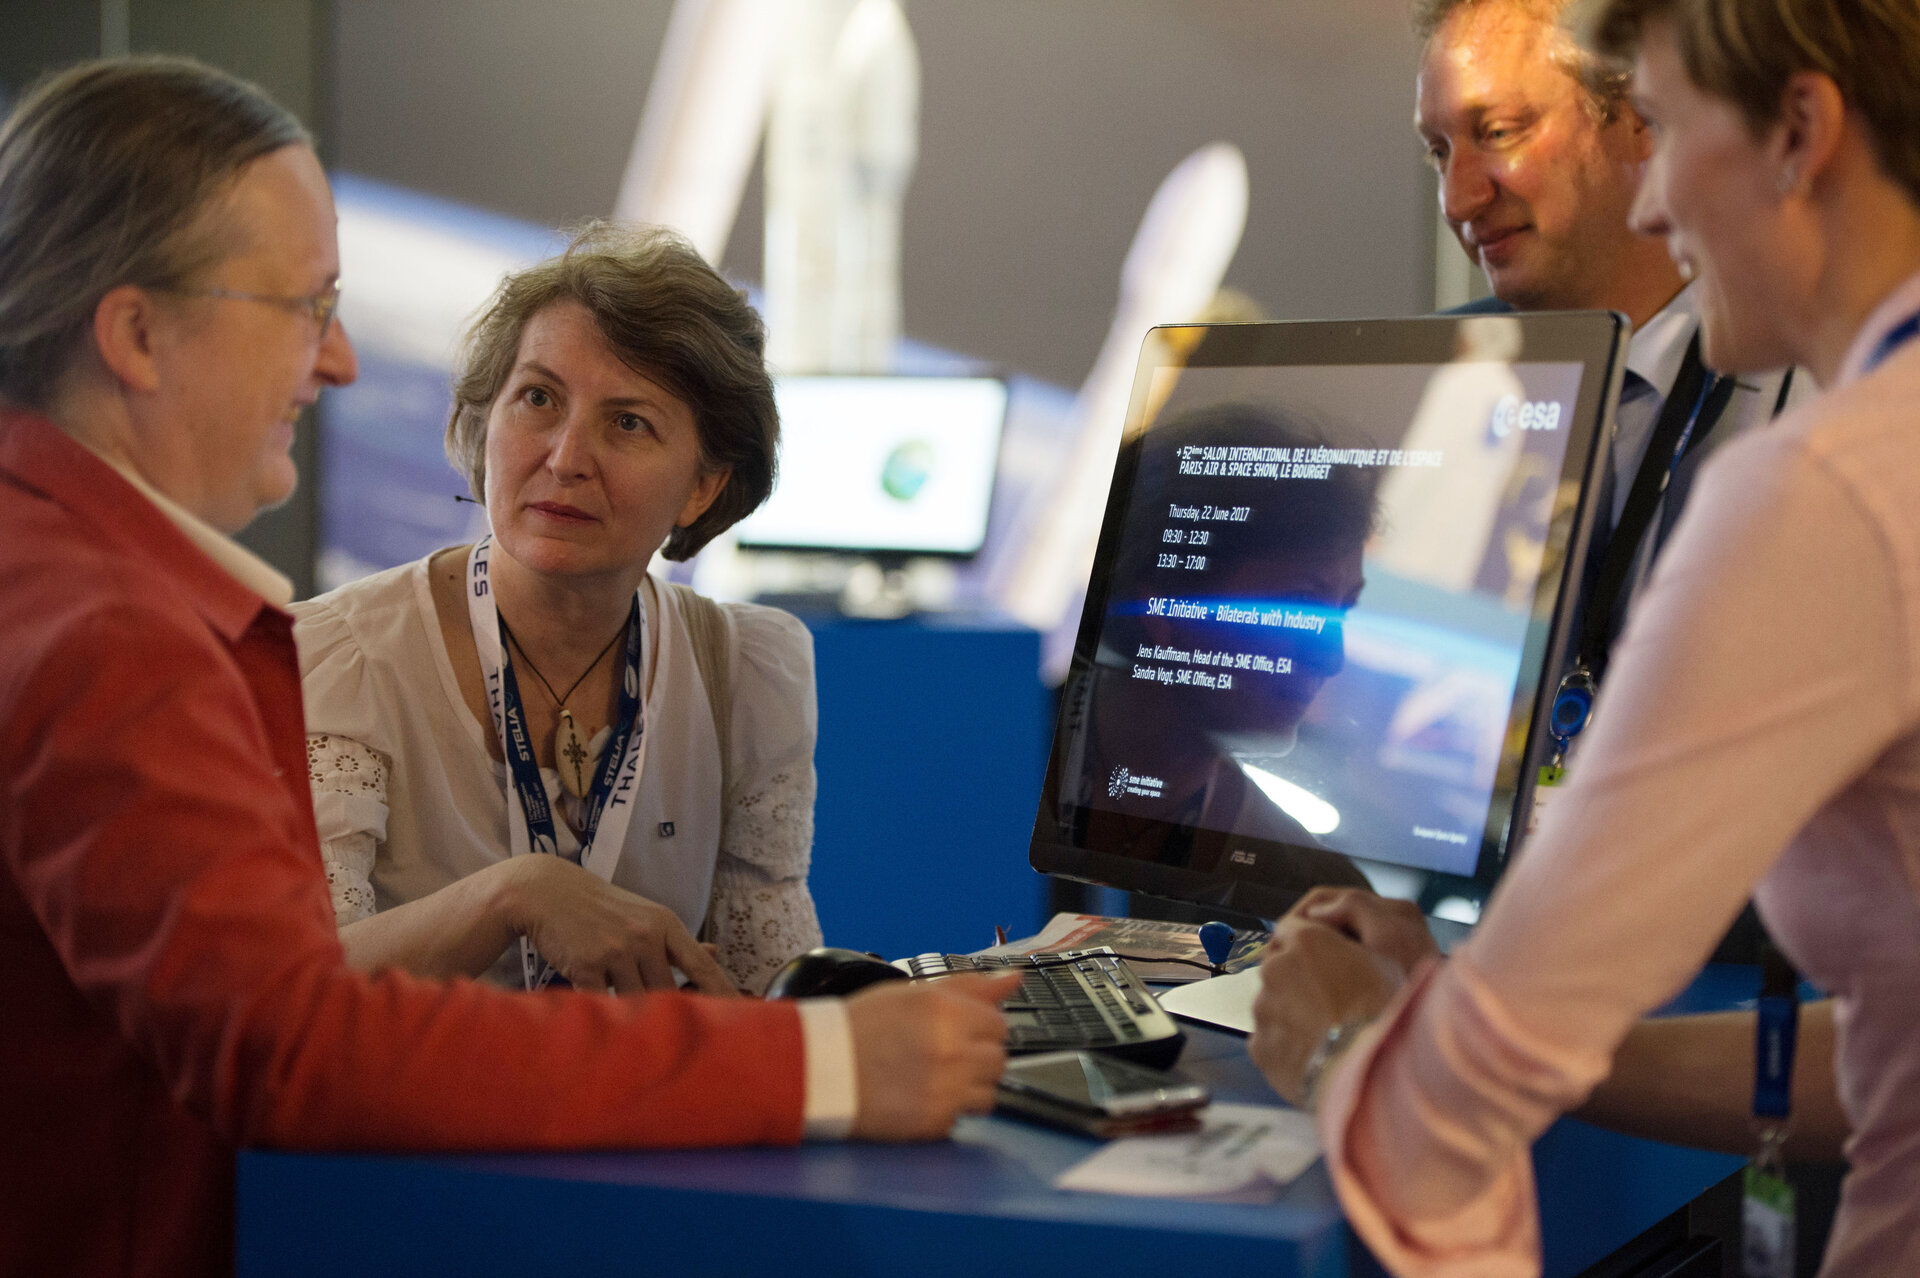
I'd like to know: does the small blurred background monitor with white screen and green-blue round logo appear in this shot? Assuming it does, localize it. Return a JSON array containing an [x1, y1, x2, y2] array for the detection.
[[739, 376, 1006, 558]]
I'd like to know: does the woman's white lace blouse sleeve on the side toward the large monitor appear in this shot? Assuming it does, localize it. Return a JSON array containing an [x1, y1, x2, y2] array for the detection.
[[712, 604, 820, 994]]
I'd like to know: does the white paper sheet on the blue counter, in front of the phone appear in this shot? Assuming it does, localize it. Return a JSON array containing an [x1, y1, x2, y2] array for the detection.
[[1054, 1103, 1321, 1197]]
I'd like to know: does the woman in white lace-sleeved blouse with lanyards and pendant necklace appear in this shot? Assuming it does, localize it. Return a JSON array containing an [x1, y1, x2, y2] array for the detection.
[[294, 225, 820, 992]]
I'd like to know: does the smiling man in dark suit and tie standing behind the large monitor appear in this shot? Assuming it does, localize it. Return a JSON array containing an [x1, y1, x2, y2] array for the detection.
[[1413, 0, 1789, 656]]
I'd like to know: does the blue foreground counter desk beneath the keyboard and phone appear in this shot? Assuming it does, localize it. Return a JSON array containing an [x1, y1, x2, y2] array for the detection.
[[238, 1029, 1740, 1278]]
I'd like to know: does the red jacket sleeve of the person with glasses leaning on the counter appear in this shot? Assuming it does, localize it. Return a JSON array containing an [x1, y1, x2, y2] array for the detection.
[[0, 591, 803, 1149]]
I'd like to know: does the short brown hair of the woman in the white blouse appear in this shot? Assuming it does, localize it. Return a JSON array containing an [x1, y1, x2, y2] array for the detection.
[[447, 221, 780, 558]]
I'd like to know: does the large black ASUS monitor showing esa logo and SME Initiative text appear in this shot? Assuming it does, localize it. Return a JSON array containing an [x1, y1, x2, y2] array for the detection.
[[1029, 313, 1626, 919]]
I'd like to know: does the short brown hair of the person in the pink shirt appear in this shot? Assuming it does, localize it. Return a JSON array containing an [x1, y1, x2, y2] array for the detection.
[[1588, 0, 1920, 203]]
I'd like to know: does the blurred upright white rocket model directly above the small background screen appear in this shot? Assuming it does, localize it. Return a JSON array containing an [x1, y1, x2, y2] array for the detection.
[[766, 0, 920, 372]]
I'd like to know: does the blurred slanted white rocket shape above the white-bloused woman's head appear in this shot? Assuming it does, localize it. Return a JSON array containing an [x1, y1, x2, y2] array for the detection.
[[614, 0, 787, 265]]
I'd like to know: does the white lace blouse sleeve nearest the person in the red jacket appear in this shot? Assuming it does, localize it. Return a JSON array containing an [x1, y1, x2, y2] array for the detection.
[[294, 587, 392, 927]]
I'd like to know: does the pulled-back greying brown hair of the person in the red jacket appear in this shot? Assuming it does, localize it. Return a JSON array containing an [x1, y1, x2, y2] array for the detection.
[[0, 56, 311, 409]]
